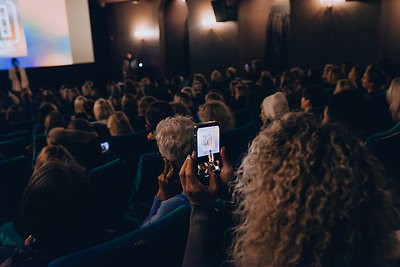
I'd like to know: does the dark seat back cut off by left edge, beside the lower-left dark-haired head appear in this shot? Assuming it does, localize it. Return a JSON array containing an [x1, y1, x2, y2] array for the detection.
[[0, 156, 32, 224]]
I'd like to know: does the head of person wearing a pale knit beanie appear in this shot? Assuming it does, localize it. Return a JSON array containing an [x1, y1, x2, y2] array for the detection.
[[260, 92, 289, 128]]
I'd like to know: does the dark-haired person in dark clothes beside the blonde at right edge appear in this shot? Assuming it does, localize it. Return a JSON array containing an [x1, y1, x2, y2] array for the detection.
[[362, 65, 393, 135]]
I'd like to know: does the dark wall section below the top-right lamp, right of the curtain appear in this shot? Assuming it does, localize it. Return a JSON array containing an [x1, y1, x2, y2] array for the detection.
[[290, 0, 380, 70]]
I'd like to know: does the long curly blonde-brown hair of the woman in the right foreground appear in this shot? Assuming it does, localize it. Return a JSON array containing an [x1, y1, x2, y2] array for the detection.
[[231, 113, 397, 266]]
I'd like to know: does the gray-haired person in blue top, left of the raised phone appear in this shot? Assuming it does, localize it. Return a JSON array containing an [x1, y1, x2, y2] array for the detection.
[[142, 115, 196, 226]]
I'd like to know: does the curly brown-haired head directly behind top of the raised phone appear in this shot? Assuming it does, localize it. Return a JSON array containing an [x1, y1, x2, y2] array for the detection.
[[198, 100, 235, 131]]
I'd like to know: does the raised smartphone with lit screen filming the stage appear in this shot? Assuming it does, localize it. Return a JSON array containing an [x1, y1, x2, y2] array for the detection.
[[194, 121, 222, 184]]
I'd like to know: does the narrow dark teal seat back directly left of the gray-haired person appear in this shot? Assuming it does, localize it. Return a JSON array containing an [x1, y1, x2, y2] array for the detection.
[[125, 152, 164, 226]]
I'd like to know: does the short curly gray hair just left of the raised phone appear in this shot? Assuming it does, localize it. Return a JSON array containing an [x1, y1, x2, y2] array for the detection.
[[155, 115, 196, 167]]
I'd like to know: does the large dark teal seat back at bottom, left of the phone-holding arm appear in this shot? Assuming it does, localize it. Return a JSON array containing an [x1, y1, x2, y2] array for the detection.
[[48, 206, 190, 267]]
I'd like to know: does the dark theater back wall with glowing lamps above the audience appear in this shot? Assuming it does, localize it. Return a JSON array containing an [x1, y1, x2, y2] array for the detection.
[[0, 0, 400, 90]]
